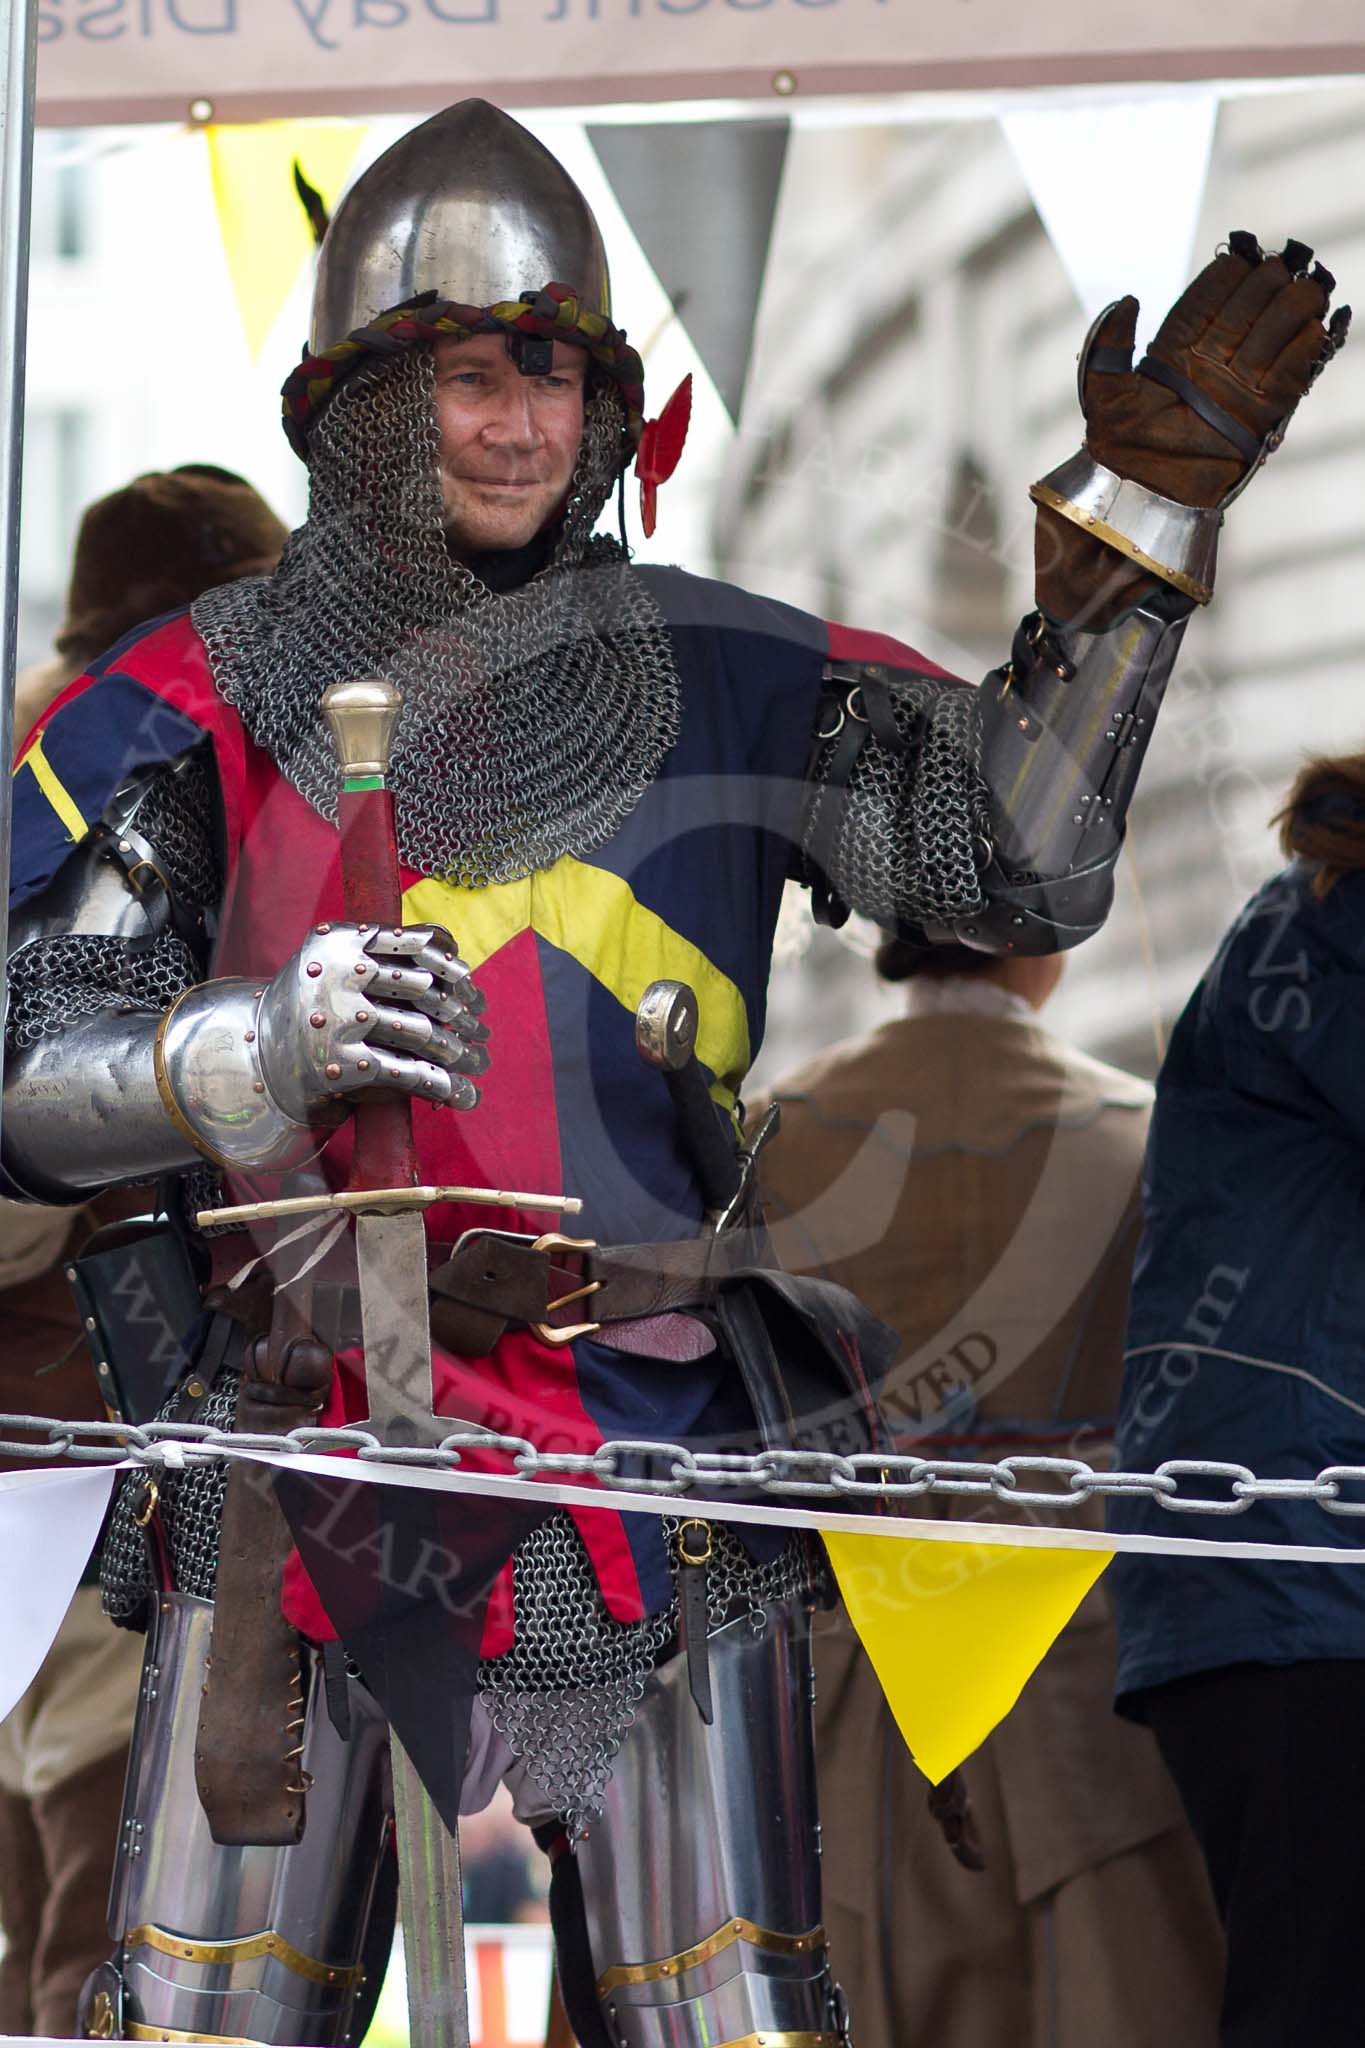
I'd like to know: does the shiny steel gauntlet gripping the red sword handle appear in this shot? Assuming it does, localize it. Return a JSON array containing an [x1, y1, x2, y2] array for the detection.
[[256, 924, 489, 1124]]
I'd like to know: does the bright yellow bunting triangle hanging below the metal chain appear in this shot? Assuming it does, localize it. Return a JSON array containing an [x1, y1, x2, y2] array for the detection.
[[825, 1530, 1113, 1784]]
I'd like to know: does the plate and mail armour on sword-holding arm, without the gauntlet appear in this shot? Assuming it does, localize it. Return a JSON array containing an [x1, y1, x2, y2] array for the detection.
[[0, 745, 317, 1202]]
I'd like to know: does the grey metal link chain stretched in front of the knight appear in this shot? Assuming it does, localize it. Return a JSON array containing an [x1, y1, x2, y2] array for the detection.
[[0, 1415, 1365, 1516]]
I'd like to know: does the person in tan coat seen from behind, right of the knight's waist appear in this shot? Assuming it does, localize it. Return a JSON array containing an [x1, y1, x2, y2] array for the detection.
[[753, 940, 1222, 2048]]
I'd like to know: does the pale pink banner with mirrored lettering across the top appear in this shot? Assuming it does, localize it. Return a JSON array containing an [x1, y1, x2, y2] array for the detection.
[[39, 0, 1365, 125]]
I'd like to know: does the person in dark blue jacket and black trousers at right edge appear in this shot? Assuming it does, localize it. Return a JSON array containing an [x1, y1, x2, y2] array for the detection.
[[1109, 754, 1365, 2048]]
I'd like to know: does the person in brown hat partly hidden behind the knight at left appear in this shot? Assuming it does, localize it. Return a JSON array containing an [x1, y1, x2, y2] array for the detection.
[[0, 465, 287, 2036]]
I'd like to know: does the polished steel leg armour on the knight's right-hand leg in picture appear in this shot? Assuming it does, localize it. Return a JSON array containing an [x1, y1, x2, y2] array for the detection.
[[575, 1602, 845, 2048]]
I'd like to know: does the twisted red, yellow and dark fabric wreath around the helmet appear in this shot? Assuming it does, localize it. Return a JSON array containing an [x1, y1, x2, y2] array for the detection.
[[280, 285, 645, 467]]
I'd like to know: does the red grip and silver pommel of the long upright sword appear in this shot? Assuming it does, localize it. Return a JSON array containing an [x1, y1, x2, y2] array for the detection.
[[321, 676, 417, 1190]]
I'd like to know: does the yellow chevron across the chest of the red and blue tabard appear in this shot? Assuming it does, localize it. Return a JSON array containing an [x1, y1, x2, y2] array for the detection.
[[403, 854, 749, 1108]]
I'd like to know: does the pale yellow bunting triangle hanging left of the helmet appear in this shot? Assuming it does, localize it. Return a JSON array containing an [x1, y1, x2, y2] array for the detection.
[[207, 121, 364, 360]]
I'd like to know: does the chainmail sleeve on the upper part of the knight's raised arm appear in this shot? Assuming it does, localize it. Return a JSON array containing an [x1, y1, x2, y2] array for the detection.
[[796, 662, 990, 932]]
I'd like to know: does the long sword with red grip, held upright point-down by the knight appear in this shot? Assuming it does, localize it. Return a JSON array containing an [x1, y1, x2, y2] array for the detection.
[[321, 680, 469, 2048]]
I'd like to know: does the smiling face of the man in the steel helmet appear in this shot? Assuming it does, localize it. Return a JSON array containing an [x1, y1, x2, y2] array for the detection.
[[432, 334, 587, 555]]
